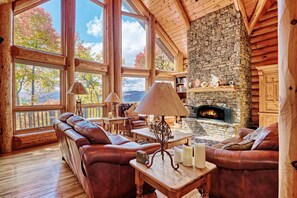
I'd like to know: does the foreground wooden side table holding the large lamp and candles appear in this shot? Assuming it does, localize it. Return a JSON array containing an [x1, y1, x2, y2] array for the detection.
[[130, 154, 216, 198]]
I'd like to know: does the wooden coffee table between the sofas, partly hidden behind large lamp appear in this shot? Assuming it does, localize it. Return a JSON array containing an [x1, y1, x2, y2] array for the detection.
[[131, 128, 193, 149]]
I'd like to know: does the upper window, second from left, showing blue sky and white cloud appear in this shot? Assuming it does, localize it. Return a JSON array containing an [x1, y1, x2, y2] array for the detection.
[[75, 0, 104, 63]]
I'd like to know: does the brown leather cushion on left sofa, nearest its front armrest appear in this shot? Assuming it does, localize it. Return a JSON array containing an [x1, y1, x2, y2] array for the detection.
[[74, 120, 111, 144]]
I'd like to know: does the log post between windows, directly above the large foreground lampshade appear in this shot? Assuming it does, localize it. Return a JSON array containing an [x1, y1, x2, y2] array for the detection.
[[146, 14, 156, 88]]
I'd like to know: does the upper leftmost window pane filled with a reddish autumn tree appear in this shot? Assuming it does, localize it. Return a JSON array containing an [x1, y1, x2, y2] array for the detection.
[[14, 0, 61, 54]]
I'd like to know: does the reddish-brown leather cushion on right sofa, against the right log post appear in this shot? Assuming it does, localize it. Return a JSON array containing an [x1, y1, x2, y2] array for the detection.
[[252, 123, 279, 150]]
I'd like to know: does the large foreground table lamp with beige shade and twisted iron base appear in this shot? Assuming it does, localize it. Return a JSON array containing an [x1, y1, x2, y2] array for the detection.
[[135, 83, 189, 170]]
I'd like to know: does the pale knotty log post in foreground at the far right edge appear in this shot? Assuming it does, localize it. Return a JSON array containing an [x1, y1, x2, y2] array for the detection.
[[278, 0, 297, 198]]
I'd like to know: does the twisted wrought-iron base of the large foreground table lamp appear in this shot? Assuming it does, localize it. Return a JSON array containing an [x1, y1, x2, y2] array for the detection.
[[145, 116, 179, 170]]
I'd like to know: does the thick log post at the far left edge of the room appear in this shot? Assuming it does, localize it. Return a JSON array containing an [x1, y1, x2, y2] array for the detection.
[[0, 3, 13, 153]]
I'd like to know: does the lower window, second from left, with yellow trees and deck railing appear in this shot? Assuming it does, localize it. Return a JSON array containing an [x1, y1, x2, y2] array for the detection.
[[75, 72, 103, 118]]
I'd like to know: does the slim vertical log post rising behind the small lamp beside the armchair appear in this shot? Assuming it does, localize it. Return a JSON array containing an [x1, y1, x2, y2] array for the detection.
[[113, 0, 122, 98]]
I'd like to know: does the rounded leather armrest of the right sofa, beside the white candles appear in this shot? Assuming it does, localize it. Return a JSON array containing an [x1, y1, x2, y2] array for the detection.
[[206, 147, 278, 170]]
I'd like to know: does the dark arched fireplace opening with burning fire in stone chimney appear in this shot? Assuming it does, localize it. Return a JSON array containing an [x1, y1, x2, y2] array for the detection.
[[188, 105, 232, 124]]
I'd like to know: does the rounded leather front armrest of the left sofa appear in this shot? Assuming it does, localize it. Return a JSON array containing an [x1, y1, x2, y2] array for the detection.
[[80, 142, 160, 166]]
